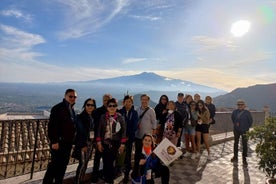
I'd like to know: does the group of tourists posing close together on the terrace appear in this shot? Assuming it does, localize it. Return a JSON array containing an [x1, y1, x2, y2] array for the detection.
[[43, 89, 252, 184]]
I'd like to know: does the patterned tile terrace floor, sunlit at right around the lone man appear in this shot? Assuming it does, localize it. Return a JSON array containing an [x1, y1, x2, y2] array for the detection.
[[0, 133, 266, 184]]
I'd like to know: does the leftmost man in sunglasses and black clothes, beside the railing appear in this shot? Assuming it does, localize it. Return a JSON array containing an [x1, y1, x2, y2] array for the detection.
[[43, 89, 77, 184]]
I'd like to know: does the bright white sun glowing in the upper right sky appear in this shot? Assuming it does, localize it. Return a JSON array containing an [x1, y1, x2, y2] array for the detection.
[[231, 20, 251, 37]]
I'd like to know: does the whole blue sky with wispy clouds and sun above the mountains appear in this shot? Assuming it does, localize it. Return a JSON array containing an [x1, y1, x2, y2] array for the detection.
[[0, 0, 276, 91]]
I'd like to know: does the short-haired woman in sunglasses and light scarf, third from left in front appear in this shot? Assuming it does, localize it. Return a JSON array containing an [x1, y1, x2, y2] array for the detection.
[[96, 98, 127, 183]]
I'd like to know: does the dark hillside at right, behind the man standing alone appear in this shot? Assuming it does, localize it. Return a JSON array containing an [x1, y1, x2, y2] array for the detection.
[[214, 83, 276, 112]]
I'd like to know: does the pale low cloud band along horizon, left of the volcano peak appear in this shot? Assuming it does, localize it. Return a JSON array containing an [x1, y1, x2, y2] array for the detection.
[[0, 57, 136, 83]]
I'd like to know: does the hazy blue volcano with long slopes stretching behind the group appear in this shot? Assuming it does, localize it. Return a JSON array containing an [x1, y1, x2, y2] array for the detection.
[[0, 72, 226, 113]]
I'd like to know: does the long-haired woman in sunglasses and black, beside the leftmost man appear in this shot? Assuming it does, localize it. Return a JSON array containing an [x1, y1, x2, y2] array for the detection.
[[72, 98, 96, 184]]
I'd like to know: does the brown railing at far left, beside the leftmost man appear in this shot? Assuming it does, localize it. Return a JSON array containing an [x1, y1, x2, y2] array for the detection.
[[0, 119, 75, 180]]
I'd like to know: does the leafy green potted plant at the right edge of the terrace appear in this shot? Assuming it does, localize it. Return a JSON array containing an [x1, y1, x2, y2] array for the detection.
[[248, 117, 276, 184]]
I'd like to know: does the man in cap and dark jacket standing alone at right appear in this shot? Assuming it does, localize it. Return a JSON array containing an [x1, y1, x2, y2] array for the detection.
[[231, 100, 253, 166]]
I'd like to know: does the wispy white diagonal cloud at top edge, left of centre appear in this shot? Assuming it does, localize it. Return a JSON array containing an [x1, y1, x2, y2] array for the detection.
[[59, 0, 129, 39]]
